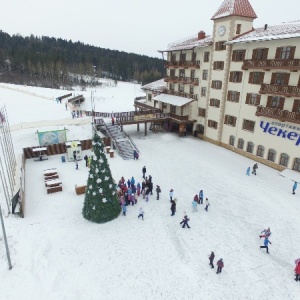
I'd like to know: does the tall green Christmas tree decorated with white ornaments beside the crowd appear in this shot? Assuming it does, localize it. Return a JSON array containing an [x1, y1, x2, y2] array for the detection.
[[82, 131, 121, 223]]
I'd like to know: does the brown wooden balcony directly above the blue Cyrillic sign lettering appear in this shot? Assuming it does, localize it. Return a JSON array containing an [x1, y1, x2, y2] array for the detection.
[[255, 106, 300, 124]]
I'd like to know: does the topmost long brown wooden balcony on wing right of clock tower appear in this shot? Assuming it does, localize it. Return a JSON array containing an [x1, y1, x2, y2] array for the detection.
[[242, 59, 300, 71]]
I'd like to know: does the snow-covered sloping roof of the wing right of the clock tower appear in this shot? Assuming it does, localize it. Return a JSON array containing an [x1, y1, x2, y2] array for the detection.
[[226, 21, 300, 44]]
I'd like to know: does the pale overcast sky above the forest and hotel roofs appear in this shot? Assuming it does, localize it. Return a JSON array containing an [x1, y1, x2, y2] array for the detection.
[[0, 0, 300, 57]]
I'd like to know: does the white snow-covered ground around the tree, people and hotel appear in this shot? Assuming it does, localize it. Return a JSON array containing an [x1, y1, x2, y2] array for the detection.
[[0, 83, 300, 300]]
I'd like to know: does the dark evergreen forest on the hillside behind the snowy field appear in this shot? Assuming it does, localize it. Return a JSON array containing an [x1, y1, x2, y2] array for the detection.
[[0, 30, 164, 88]]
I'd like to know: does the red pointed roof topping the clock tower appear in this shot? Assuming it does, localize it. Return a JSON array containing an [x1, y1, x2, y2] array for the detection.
[[211, 0, 257, 20]]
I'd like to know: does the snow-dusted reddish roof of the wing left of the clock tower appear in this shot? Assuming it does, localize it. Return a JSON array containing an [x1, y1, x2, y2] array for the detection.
[[159, 35, 213, 52]]
